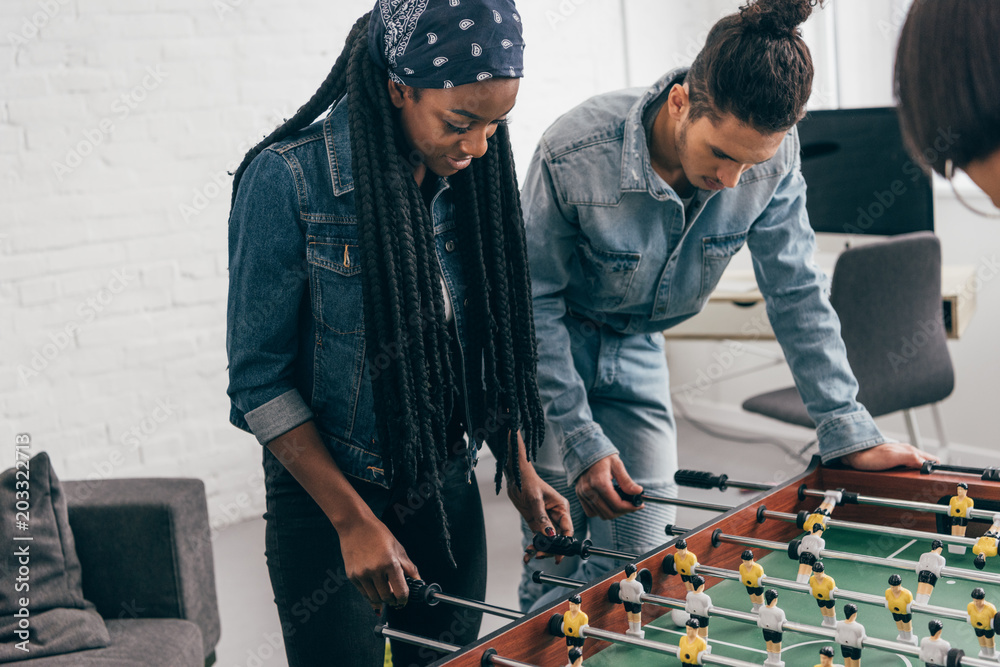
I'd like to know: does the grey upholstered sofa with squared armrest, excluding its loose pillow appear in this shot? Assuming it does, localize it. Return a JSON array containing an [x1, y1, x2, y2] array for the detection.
[[17, 479, 220, 667]]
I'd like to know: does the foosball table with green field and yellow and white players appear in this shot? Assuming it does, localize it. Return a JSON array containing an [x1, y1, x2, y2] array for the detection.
[[377, 460, 1000, 667]]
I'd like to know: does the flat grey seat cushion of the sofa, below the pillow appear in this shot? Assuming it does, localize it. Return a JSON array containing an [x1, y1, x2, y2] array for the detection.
[[6, 618, 205, 667]]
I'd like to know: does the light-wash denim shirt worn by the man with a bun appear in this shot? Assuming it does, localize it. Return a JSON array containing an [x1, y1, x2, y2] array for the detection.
[[521, 69, 885, 479]]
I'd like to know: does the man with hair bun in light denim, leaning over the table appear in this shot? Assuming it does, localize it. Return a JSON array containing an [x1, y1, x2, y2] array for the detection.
[[521, 0, 927, 610]]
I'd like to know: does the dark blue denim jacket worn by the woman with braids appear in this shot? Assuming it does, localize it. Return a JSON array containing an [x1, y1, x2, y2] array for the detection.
[[226, 98, 481, 488]]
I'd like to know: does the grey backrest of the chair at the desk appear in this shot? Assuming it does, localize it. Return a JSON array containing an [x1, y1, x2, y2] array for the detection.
[[830, 232, 955, 417]]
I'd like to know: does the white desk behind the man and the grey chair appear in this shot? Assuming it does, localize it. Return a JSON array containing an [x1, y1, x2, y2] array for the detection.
[[663, 263, 976, 340]]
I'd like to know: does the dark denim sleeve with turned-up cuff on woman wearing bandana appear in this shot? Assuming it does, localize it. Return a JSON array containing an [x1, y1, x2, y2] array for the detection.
[[226, 150, 313, 445]]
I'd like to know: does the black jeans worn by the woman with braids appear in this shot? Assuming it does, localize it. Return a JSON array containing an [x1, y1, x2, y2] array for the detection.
[[263, 439, 486, 667]]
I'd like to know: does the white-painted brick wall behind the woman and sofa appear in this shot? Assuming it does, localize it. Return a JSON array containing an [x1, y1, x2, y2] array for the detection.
[[0, 0, 668, 540]]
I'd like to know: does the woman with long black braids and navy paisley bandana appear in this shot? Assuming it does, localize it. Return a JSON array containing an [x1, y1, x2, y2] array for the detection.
[[227, 0, 572, 666]]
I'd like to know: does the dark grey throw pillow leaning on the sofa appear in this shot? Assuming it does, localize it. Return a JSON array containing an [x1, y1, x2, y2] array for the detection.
[[0, 452, 110, 663]]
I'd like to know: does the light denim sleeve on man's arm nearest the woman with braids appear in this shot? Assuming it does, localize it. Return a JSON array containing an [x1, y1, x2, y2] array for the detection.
[[521, 144, 618, 484]]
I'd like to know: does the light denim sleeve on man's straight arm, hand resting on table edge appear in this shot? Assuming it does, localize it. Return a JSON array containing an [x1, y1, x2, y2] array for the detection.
[[747, 140, 886, 462]]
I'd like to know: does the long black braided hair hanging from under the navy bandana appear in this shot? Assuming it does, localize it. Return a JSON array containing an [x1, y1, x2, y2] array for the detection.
[[233, 14, 544, 554]]
